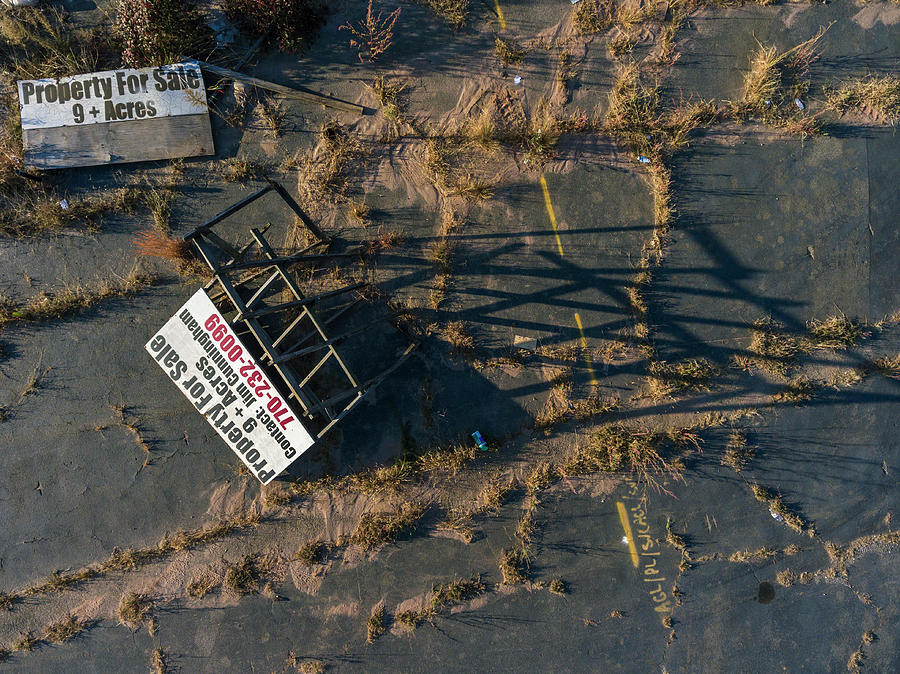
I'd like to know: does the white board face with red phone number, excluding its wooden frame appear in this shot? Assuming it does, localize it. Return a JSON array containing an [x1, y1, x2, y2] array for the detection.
[[146, 288, 315, 484]]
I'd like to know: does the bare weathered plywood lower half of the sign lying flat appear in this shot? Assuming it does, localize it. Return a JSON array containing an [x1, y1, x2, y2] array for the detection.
[[22, 112, 215, 169]]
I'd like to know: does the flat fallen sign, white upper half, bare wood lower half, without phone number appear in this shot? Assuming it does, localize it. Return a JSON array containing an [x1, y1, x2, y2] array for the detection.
[[18, 61, 214, 169]]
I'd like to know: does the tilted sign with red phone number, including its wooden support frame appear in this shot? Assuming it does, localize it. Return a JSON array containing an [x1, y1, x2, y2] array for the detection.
[[146, 178, 418, 484]]
